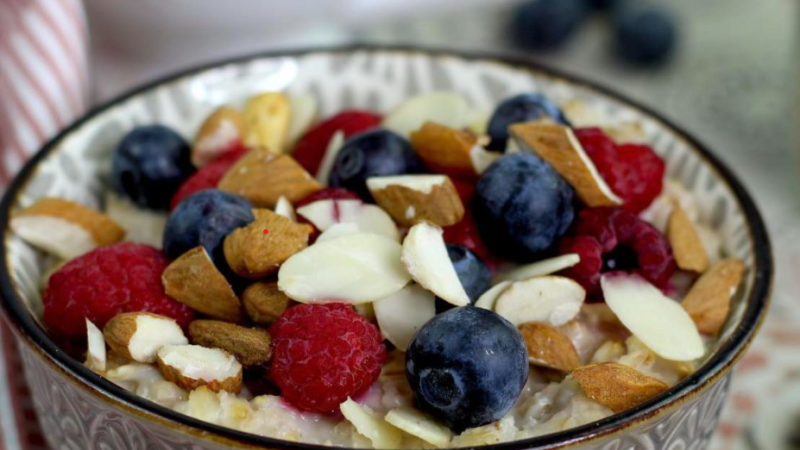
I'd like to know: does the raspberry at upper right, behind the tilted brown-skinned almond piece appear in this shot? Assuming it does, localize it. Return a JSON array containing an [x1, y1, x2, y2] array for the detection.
[[575, 128, 665, 212]]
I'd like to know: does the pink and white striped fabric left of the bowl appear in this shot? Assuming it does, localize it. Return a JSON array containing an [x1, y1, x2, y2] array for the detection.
[[0, 0, 89, 450]]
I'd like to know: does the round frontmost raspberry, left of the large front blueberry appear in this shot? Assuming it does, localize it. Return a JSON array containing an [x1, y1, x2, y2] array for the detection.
[[269, 303, 386, 414]]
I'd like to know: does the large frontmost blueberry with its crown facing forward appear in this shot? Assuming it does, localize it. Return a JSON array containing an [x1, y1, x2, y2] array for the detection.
[[406, 306, 528, 433]]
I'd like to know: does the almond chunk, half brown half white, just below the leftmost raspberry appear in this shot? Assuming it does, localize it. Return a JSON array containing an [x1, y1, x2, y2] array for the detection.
[[103, 312, 189, 363]]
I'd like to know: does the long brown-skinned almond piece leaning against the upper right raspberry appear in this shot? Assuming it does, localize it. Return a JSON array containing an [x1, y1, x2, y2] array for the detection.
[[509, 122, 622, 207]]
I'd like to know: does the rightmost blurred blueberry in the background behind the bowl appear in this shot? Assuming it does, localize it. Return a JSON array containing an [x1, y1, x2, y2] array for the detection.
[[614, 6, 678, 65]]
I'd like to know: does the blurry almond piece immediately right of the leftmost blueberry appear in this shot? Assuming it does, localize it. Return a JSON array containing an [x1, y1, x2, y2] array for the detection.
[[192, 105, 247, 167]]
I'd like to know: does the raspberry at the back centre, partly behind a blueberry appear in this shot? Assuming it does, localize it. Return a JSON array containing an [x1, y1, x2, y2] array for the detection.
[[293, 110, 382, 175]]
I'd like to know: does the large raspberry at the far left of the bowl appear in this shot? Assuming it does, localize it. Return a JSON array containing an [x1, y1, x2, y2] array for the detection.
[[44, 242, 194, 338]]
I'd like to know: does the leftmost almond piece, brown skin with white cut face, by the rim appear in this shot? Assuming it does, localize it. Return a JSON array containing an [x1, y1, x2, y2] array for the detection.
[[10, 197, 125, 259]]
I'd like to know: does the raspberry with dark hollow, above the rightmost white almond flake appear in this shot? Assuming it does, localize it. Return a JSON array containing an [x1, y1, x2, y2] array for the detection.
[[559, 208, 675, 296]]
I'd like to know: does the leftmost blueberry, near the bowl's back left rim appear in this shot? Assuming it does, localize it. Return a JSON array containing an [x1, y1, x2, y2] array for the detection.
[[111, 125, 195, 211]]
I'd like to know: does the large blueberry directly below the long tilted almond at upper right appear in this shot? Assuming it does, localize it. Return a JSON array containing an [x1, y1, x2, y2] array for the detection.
[[472, 153, 574, 260]]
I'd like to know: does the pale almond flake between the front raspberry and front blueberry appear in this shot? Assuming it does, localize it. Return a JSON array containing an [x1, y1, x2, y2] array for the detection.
[[372, 284, 436, 351]]
